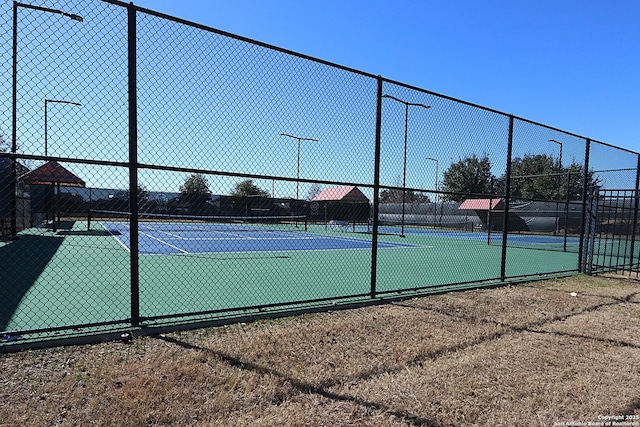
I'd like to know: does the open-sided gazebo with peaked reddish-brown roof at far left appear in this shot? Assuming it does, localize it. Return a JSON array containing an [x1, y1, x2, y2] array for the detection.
[[19, 161, 85, 231]]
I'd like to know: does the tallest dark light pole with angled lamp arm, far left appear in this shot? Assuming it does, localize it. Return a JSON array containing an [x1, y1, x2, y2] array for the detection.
[[11, 1, 84, 239]]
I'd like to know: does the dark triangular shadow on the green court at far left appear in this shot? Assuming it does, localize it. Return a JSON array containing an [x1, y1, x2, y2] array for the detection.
[[0, 235, 64, 331]]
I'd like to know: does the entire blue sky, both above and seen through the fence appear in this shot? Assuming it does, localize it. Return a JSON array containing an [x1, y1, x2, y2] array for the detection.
[[0, 0, 640, 197]]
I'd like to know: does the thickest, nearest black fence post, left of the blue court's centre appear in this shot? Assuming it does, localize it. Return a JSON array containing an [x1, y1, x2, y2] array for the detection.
[[127, 3, 140, 327]]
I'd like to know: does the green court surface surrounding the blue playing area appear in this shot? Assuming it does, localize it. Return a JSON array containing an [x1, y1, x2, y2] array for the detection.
[[0, 222, 577, 338]]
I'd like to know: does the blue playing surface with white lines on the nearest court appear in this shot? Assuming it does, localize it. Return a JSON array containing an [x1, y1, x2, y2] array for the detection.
[[102, 222, 419, 255]]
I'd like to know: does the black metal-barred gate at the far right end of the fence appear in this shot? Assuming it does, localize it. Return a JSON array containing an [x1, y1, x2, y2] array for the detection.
[[582, 187, 640, 276]]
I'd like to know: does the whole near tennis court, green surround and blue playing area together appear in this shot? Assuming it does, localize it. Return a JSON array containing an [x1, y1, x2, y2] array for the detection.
[[0, 214, 577, 344]]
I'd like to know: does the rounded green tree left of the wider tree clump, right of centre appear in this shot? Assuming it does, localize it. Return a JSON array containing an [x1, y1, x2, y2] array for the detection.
[[442, 154, 495, 202]]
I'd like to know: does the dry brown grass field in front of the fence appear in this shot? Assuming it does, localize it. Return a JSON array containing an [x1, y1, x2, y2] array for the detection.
[[0, 276, 640, 427]]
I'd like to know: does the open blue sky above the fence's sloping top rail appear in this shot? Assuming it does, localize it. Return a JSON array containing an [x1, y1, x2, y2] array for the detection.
[[134, 0, 640, 151]]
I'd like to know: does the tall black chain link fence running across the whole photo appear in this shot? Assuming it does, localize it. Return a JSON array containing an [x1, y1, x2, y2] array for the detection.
[[0, 0, 638, 348]]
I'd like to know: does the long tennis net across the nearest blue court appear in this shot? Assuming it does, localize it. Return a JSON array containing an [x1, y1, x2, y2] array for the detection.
[[87, 210, 307, 233]]
